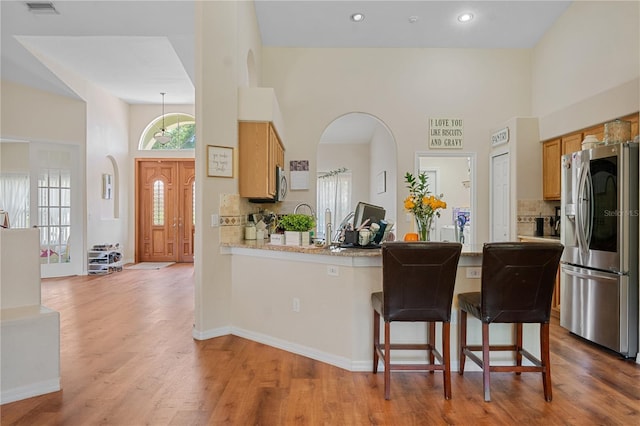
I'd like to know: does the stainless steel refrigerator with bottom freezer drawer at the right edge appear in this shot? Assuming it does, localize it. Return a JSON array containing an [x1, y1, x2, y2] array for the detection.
[[560, 142, 639, 357]]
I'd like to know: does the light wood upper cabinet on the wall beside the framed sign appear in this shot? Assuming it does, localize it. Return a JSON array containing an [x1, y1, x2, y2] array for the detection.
[[238, 121, 284, 200]]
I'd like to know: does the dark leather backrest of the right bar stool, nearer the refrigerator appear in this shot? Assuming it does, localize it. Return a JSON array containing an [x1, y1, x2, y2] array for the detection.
[[481, 242, 564, 323]]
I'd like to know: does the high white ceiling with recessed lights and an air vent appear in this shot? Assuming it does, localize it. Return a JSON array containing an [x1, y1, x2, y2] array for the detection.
[[0, 0, 571, 104]]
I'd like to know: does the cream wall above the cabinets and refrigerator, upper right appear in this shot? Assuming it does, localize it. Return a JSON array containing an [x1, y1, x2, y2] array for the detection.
[[531, 1, 640, 139]]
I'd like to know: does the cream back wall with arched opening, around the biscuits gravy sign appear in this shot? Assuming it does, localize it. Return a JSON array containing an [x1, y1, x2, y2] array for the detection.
[[262, 47, 531, 241]]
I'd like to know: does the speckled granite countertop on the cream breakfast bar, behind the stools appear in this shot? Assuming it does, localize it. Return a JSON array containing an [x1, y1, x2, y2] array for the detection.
[[220, 240, 482, 257]]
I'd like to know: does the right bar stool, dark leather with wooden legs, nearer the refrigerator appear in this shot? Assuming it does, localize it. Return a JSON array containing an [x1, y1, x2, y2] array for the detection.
[[458, 243, 564, 401]]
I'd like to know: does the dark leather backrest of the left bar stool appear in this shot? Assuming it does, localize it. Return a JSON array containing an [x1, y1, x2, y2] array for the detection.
[[382, 242, 462, 322]]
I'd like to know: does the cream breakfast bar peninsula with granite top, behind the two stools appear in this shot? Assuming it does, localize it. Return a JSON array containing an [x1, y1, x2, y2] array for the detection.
[[215, 241, 539, 371]]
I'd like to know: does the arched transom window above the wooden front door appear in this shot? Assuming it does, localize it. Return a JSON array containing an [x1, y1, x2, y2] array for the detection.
[[138, 113, 196, 151]]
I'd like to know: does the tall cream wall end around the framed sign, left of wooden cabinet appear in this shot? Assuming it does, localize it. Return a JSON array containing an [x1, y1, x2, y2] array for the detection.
[[193, 2, 264, 338]]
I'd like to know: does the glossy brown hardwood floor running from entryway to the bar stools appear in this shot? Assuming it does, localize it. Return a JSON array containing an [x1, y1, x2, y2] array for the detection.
[[1, 264, 640, 426]]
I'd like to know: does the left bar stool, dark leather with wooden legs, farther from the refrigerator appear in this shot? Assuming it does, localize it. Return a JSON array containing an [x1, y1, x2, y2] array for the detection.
[[371, 242, 462, 399]]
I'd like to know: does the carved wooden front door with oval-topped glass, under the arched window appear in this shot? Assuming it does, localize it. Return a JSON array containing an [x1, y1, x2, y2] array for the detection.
[[136, 159, 195, 262]]
